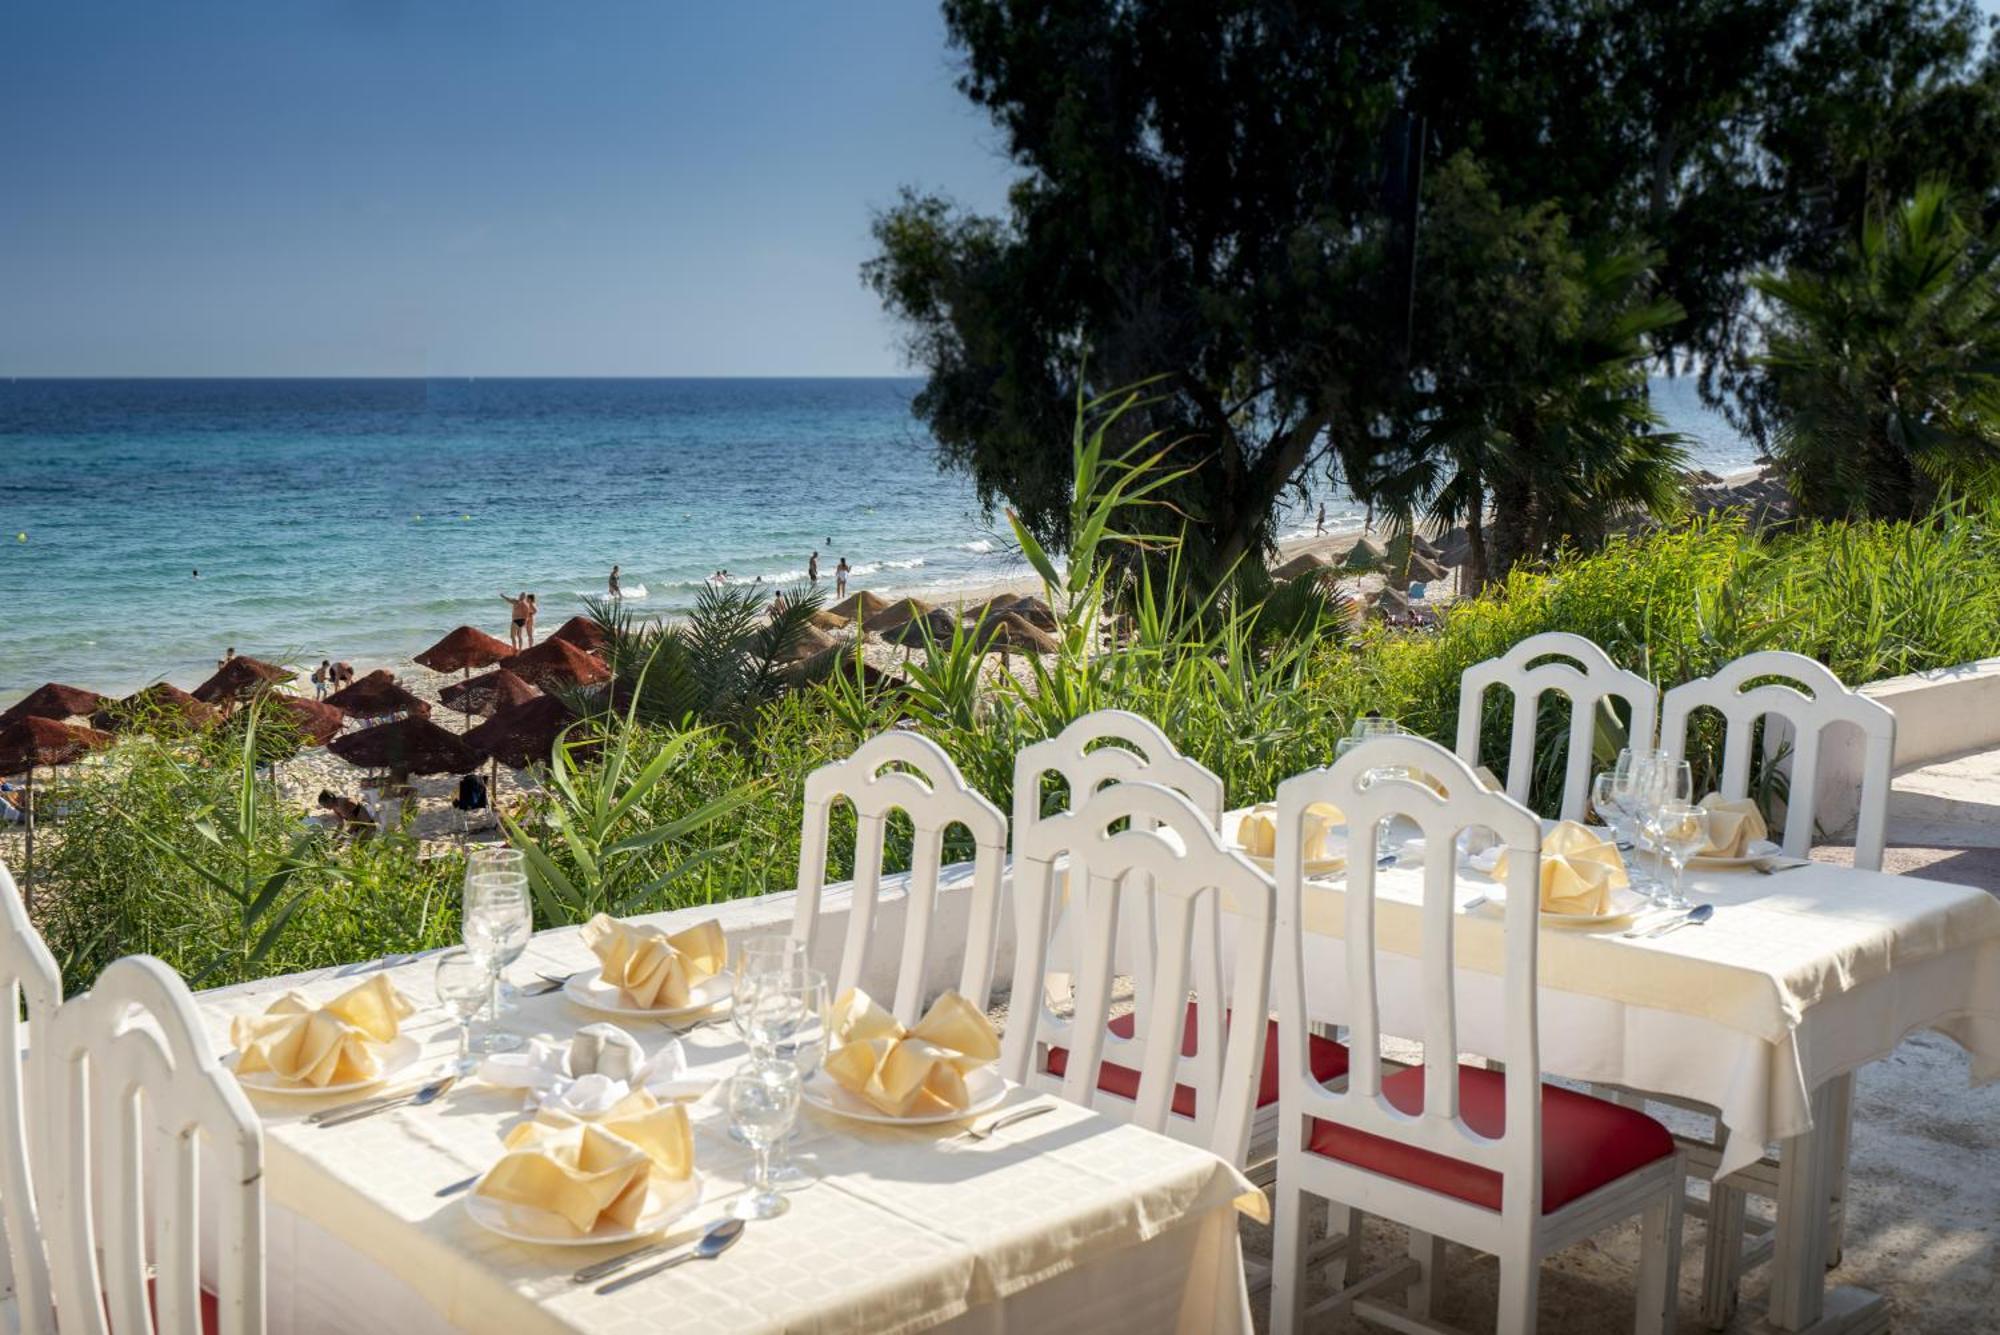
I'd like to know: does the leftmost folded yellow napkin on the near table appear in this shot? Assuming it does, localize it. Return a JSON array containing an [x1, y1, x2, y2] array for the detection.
[[230, 973, 416, 1089]]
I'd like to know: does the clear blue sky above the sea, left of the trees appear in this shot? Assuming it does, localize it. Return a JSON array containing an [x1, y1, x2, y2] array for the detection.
[[0, 0, 1008, 376]]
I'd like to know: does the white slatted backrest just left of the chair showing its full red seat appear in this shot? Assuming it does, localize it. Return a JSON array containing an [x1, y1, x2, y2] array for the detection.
[[1000, 781, 1272, 1163]]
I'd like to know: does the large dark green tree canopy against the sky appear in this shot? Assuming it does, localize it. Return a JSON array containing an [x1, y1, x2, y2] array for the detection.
[[864, 0, 2000, 570]]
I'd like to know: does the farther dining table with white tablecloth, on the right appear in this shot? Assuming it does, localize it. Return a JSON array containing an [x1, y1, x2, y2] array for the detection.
[[1200, 811, 2000, 1331]]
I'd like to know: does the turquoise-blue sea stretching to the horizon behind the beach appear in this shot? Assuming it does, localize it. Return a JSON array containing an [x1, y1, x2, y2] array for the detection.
[[0, 378, 1754, 705]]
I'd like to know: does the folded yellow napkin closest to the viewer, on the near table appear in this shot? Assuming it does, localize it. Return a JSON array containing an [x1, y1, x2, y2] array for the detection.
[[472, 1089, 694, 1237]]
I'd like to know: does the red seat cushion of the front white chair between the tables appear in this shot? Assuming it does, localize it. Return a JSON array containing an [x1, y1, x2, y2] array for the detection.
[[1306, 1065, 1674, 1215]]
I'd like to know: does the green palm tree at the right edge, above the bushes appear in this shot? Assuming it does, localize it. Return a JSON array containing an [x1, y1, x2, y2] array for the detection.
[[1752, 182, 2000, 520]]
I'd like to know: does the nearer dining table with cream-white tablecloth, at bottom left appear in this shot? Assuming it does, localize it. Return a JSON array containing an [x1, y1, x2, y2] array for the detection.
[[198, 911, 1264, 1335]]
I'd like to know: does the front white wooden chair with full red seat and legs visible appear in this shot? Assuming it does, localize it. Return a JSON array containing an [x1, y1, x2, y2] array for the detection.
[[1272, 735, 1682, 1335]]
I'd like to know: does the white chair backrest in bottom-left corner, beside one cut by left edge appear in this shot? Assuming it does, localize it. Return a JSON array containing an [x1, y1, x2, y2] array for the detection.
[[38, 955, 264, 1335]]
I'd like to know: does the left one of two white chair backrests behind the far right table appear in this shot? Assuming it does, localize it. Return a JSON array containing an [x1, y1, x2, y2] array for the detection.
[[1458, 630, 1660, 821]]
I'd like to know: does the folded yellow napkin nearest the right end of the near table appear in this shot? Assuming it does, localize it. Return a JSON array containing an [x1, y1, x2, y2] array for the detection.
[[826, 987, 1000, 1117]]
